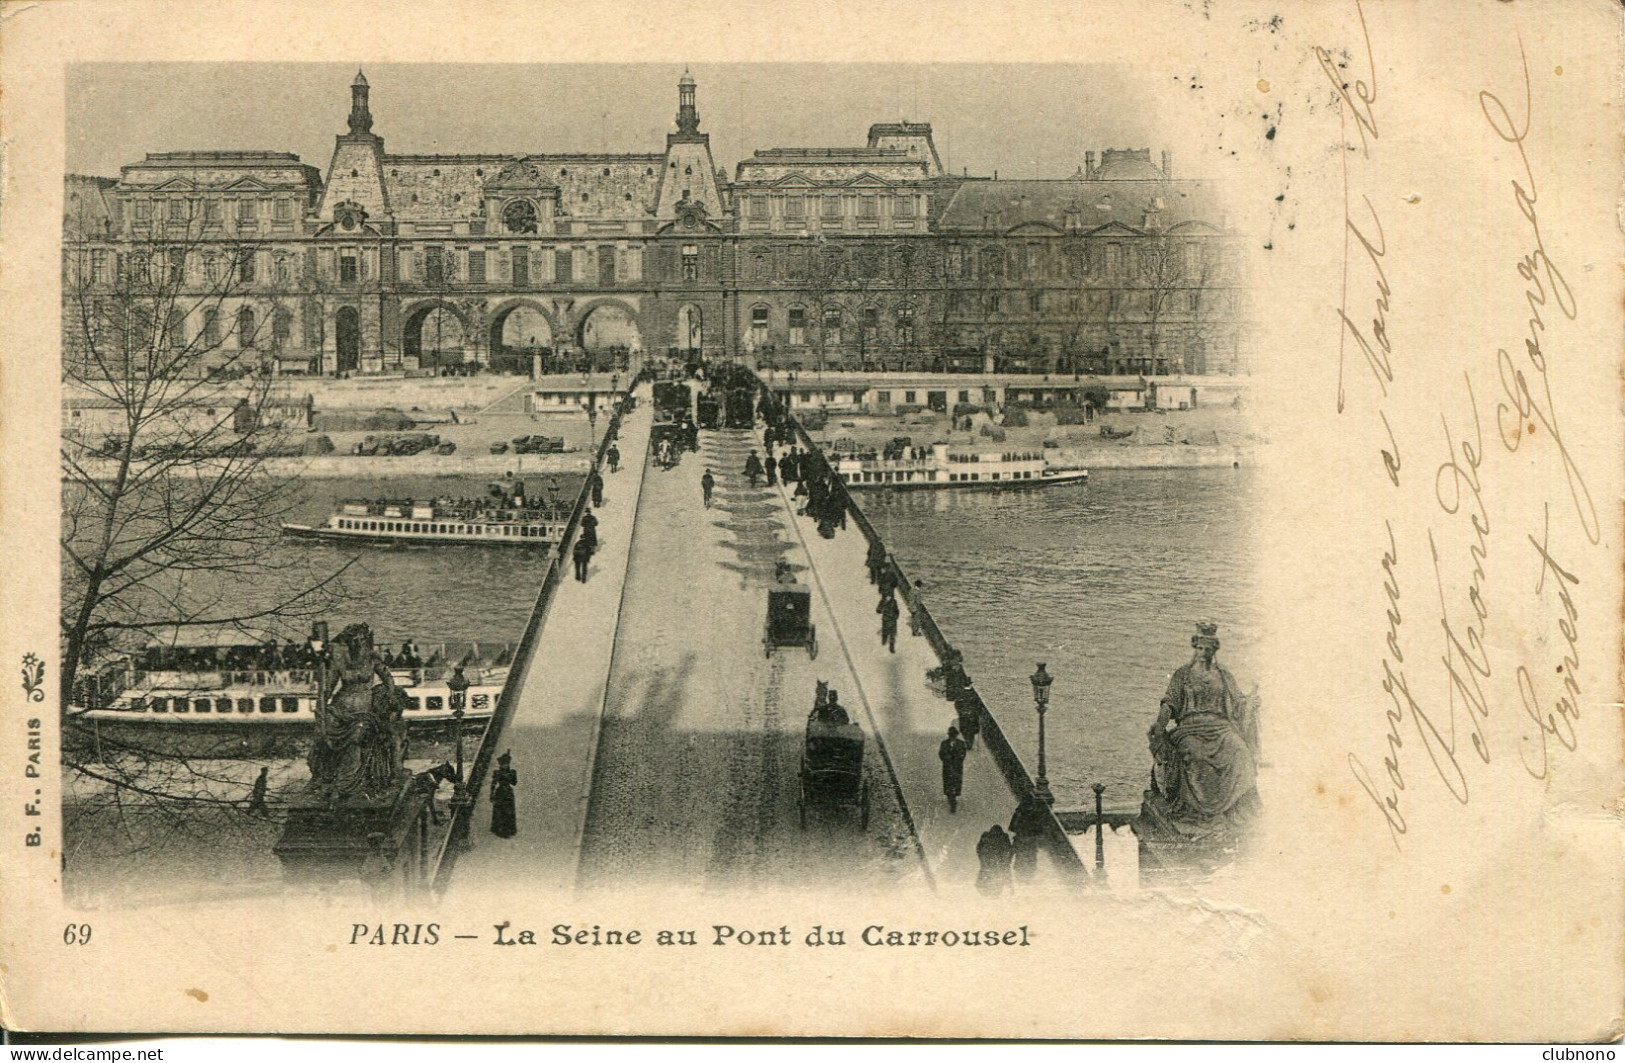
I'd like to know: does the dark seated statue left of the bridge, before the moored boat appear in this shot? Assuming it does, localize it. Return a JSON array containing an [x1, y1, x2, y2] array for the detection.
[[309, 624, 406, 806]]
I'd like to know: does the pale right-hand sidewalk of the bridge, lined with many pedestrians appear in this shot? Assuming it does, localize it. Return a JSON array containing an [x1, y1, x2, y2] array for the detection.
[[780, 468, 1072, 892]]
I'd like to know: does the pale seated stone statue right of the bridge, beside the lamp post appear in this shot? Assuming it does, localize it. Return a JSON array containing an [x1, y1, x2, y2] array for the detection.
[[1151, 623, 1259, 834]]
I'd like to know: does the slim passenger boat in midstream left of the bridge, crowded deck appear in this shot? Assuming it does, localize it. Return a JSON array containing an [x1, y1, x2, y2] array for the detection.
[[283, 496, 570, 548]]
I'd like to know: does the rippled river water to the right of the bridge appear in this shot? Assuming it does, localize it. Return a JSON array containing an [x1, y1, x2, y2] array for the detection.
[[858, 468, 1269, 808]]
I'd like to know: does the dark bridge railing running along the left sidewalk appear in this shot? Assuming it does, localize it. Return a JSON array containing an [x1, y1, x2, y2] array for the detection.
[[427, 386, 642, 894]]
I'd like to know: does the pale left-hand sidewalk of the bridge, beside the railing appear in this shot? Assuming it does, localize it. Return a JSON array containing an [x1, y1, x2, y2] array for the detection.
[[452, 385, 653, 896]]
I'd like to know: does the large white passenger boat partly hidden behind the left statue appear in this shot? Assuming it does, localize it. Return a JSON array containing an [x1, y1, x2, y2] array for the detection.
[[67, 627, 514, 757]]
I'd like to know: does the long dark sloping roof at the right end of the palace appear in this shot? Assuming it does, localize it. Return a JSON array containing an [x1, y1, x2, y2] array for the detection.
[[936, 179, 1224, 232]]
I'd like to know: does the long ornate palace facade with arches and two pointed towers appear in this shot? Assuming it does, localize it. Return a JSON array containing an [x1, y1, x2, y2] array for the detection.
[[63, 73, 1246, 374]]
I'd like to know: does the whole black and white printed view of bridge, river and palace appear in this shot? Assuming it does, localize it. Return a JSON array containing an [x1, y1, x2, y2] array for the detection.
[[60, 63, 1264, 907]]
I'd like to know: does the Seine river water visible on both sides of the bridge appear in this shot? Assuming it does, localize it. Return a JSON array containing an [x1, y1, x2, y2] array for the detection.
[[73, 470, 1269, 806]]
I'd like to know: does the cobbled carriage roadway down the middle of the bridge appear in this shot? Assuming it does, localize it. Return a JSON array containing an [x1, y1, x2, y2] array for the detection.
[[579, 431, 925, 889]]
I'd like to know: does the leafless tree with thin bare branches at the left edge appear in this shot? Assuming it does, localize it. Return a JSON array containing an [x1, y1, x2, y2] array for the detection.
[[60, 223, 354, 724]]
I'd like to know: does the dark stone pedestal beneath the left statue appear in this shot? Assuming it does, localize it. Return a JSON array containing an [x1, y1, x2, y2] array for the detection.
[[271, 772, 424, 884]]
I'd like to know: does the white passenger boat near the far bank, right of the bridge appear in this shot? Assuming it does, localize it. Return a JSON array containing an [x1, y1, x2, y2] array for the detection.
[[830, 444, 1089, 491]]
